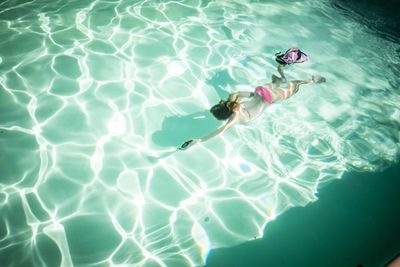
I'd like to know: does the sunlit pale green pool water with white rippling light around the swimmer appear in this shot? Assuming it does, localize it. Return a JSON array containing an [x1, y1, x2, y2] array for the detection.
[[0, 0, 400, 266]]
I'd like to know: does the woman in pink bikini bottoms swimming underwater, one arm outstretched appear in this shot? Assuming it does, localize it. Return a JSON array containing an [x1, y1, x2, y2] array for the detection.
[[179, 49, 326, 150]]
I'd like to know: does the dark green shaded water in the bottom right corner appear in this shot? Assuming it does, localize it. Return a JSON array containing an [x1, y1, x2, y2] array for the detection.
[[206, 165, 400, 267]]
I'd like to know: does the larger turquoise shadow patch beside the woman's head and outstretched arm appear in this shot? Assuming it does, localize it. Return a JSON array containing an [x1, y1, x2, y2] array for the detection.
[[152, 110, 220, 147]]
